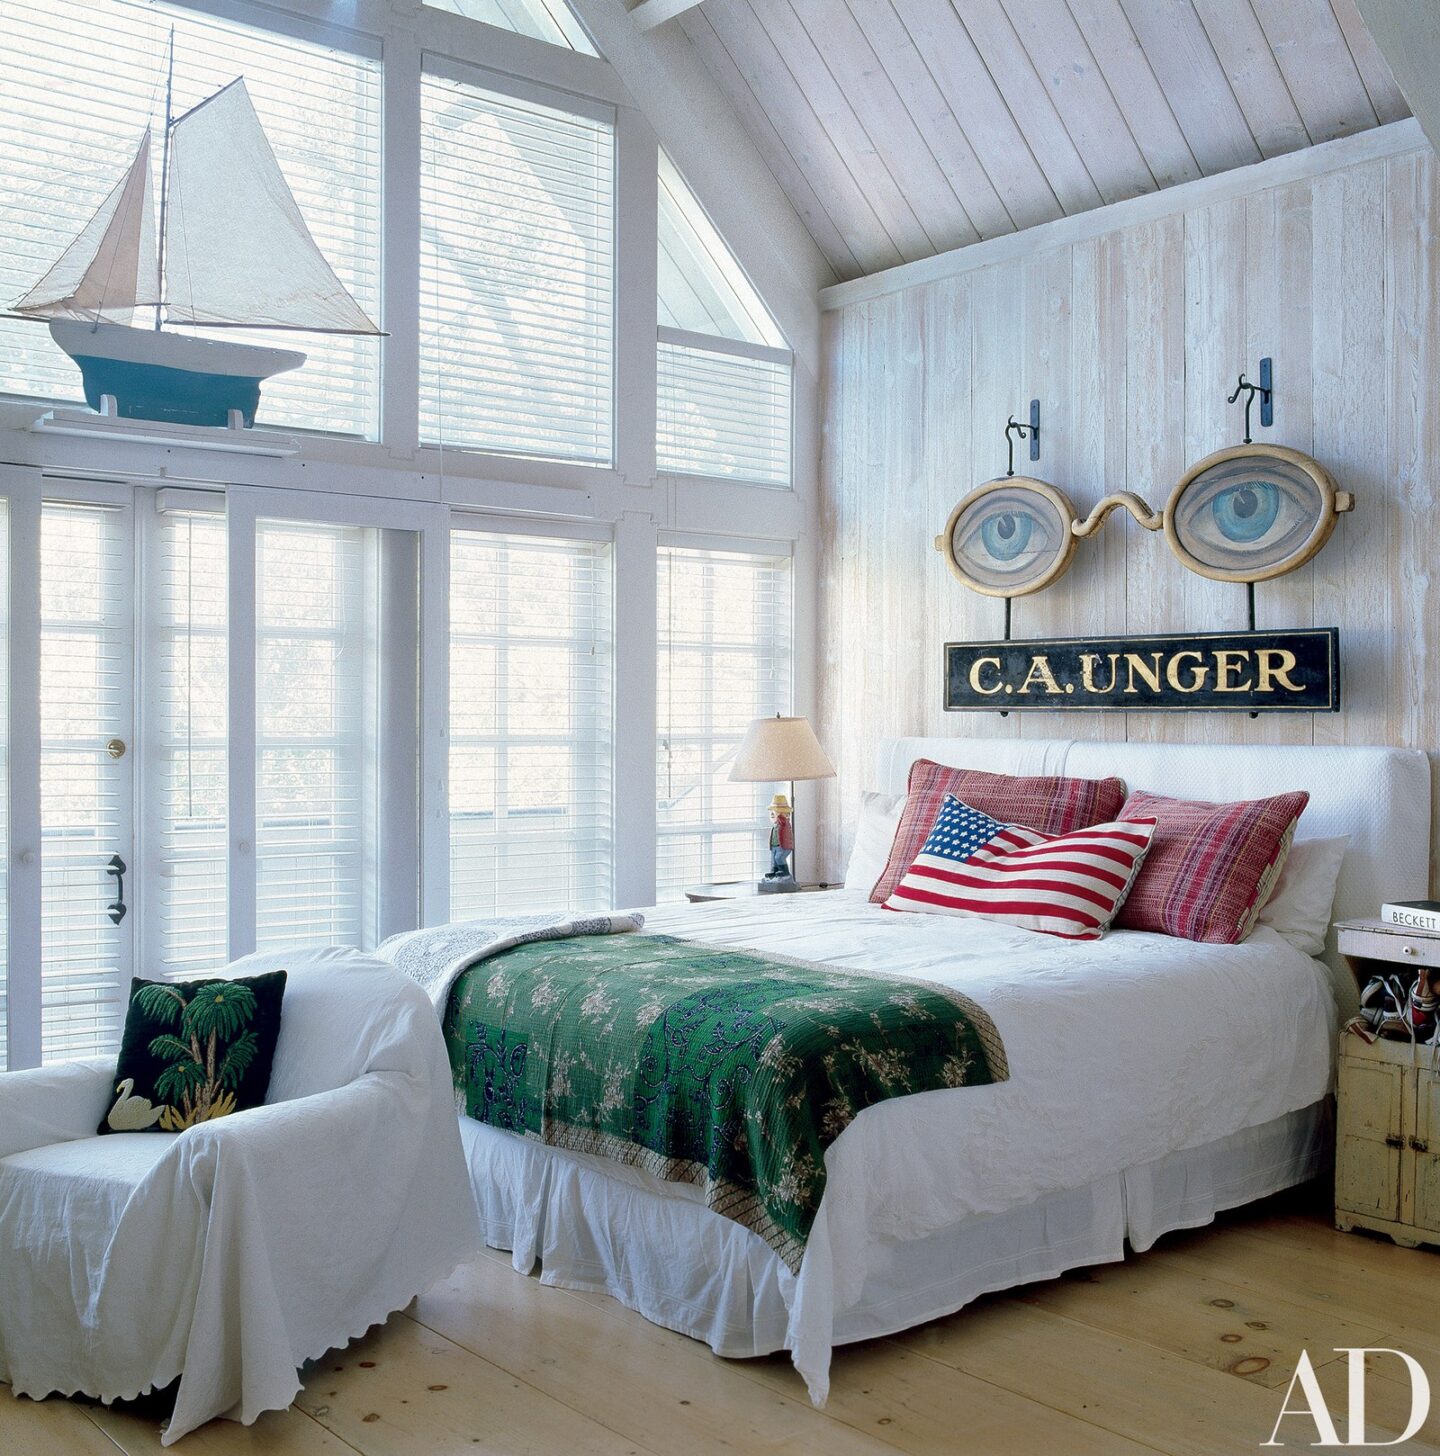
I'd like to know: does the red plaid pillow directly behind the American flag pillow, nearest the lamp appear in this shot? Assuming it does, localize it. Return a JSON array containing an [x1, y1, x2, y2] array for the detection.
[[871, 759, 1126, 904]]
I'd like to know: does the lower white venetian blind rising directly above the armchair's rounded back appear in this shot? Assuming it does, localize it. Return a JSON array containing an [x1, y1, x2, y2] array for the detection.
[[255, 520, 377, 949]]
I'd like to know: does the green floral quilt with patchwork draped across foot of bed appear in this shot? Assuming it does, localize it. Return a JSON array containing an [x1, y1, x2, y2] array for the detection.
[[444, 935, 1009, 1270]]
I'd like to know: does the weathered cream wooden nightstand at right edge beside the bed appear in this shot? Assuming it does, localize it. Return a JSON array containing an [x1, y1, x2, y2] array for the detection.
[[1335, 920, 1440, 1249]]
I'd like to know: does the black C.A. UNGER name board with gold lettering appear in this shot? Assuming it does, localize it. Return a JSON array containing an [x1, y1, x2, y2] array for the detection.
[[945, 628, 1340, 713]]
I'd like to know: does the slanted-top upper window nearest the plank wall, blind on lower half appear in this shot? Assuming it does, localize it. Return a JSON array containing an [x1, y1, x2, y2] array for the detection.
[[655, 151, 795, 486]]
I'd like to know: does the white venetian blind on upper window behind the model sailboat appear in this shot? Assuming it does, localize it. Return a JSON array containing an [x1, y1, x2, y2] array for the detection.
[[0, 0, 381, 437]]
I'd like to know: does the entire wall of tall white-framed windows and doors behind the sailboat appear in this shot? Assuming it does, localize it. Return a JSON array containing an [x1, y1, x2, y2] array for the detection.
[[0, 0, 810, 1069]]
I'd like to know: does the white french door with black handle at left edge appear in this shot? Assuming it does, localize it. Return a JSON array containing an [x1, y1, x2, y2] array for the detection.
[[0, 470, 135, 1066]]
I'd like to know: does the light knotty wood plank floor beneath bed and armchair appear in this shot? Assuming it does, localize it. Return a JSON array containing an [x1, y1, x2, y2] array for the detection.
[[0, 1198, 1440, 1456]]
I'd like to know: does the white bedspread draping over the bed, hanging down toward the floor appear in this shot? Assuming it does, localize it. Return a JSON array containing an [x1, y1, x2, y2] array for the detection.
[[646, 891, 1338, 1399]]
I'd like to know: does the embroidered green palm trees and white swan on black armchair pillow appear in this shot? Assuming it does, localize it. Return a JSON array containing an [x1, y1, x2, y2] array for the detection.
[[108, 981, 259, 1133]]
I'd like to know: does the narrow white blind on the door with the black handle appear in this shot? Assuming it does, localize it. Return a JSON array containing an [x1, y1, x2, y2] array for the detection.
[[39, 501, 134, 1061]]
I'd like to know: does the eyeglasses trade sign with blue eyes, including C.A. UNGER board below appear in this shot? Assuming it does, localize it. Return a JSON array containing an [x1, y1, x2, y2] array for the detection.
[[935, 372, 1354, 716]]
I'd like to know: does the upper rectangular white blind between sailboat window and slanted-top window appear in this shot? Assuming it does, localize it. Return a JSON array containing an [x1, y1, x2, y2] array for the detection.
[[421, 73, 614, 464]]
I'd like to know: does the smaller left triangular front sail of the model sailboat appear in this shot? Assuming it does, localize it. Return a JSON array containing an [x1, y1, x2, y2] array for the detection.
[[13, 131, 159, 323]]
